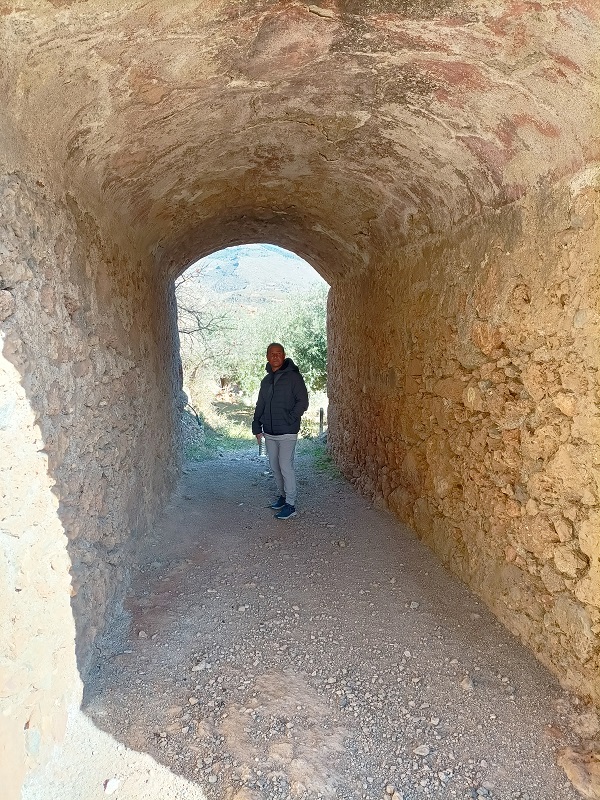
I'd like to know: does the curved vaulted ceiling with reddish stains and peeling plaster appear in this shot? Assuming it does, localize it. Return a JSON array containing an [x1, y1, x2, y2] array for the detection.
[[0, 0, 600, 280]]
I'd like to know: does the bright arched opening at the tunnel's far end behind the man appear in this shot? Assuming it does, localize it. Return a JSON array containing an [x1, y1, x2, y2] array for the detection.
[[175, 244, 328, 457]]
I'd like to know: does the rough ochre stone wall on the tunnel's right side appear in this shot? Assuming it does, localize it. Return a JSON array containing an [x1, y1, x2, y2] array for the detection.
[[330, 170, 600, 703]]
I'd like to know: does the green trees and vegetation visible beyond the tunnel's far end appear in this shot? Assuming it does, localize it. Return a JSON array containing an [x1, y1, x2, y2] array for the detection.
[[176, 250, 328, 460]]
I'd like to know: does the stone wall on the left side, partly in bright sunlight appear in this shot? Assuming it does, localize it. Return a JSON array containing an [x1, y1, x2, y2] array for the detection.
[[0, 174, 177, 797]]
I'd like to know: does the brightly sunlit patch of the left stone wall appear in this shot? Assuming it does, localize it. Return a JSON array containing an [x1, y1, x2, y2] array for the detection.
[[0, 324, 81, 800]]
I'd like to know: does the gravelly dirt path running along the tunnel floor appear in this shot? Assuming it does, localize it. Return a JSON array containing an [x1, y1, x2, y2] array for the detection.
[[24, 448, 594, 800]]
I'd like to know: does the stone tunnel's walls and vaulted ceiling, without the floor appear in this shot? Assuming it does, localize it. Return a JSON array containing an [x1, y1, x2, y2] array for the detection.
[[0, 0, 600, 798]]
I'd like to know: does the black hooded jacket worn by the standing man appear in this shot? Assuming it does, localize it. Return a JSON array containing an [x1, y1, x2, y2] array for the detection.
[[252, 358, 308, 436]]
